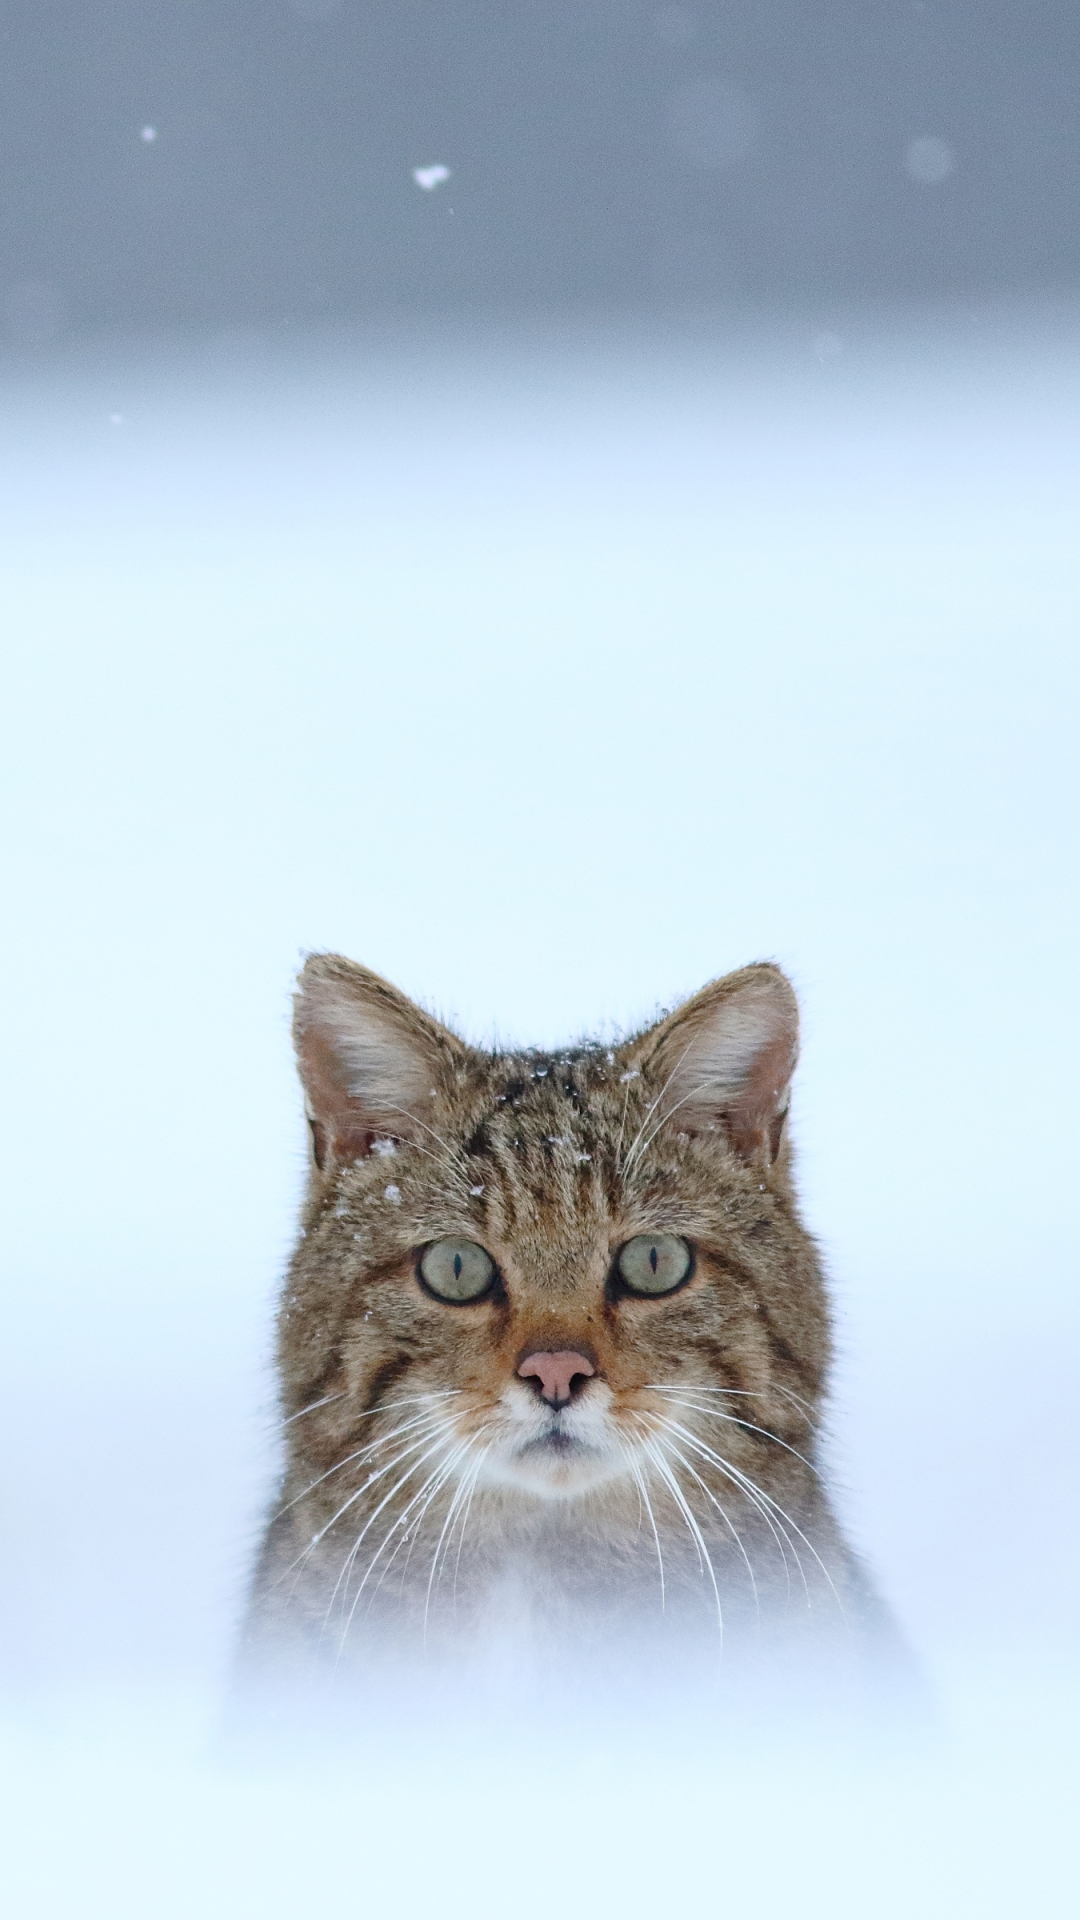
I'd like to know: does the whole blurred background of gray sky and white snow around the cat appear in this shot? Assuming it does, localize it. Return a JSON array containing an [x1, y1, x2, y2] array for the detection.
[[0, 0, 1080, 1920]]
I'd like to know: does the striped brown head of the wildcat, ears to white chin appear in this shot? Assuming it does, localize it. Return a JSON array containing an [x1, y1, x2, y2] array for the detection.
[[281, 954, 828, 1500]]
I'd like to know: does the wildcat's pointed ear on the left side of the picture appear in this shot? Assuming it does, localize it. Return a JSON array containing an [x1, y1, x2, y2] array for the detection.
[[292, 954, 465, 1169]]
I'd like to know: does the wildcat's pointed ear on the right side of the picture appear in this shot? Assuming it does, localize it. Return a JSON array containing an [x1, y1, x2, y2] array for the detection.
[[648, 966, 799, 1162]]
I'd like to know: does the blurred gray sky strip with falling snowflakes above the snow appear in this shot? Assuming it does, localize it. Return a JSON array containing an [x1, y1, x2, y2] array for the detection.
[[0, 0, 1080, 346]]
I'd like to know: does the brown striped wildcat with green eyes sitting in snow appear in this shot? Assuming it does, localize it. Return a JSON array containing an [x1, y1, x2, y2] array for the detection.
[[248, 954, 890, 1689]]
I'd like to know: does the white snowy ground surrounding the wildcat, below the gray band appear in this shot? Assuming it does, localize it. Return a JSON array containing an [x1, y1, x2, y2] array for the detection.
[[0, 315, 1080, 1920]]
